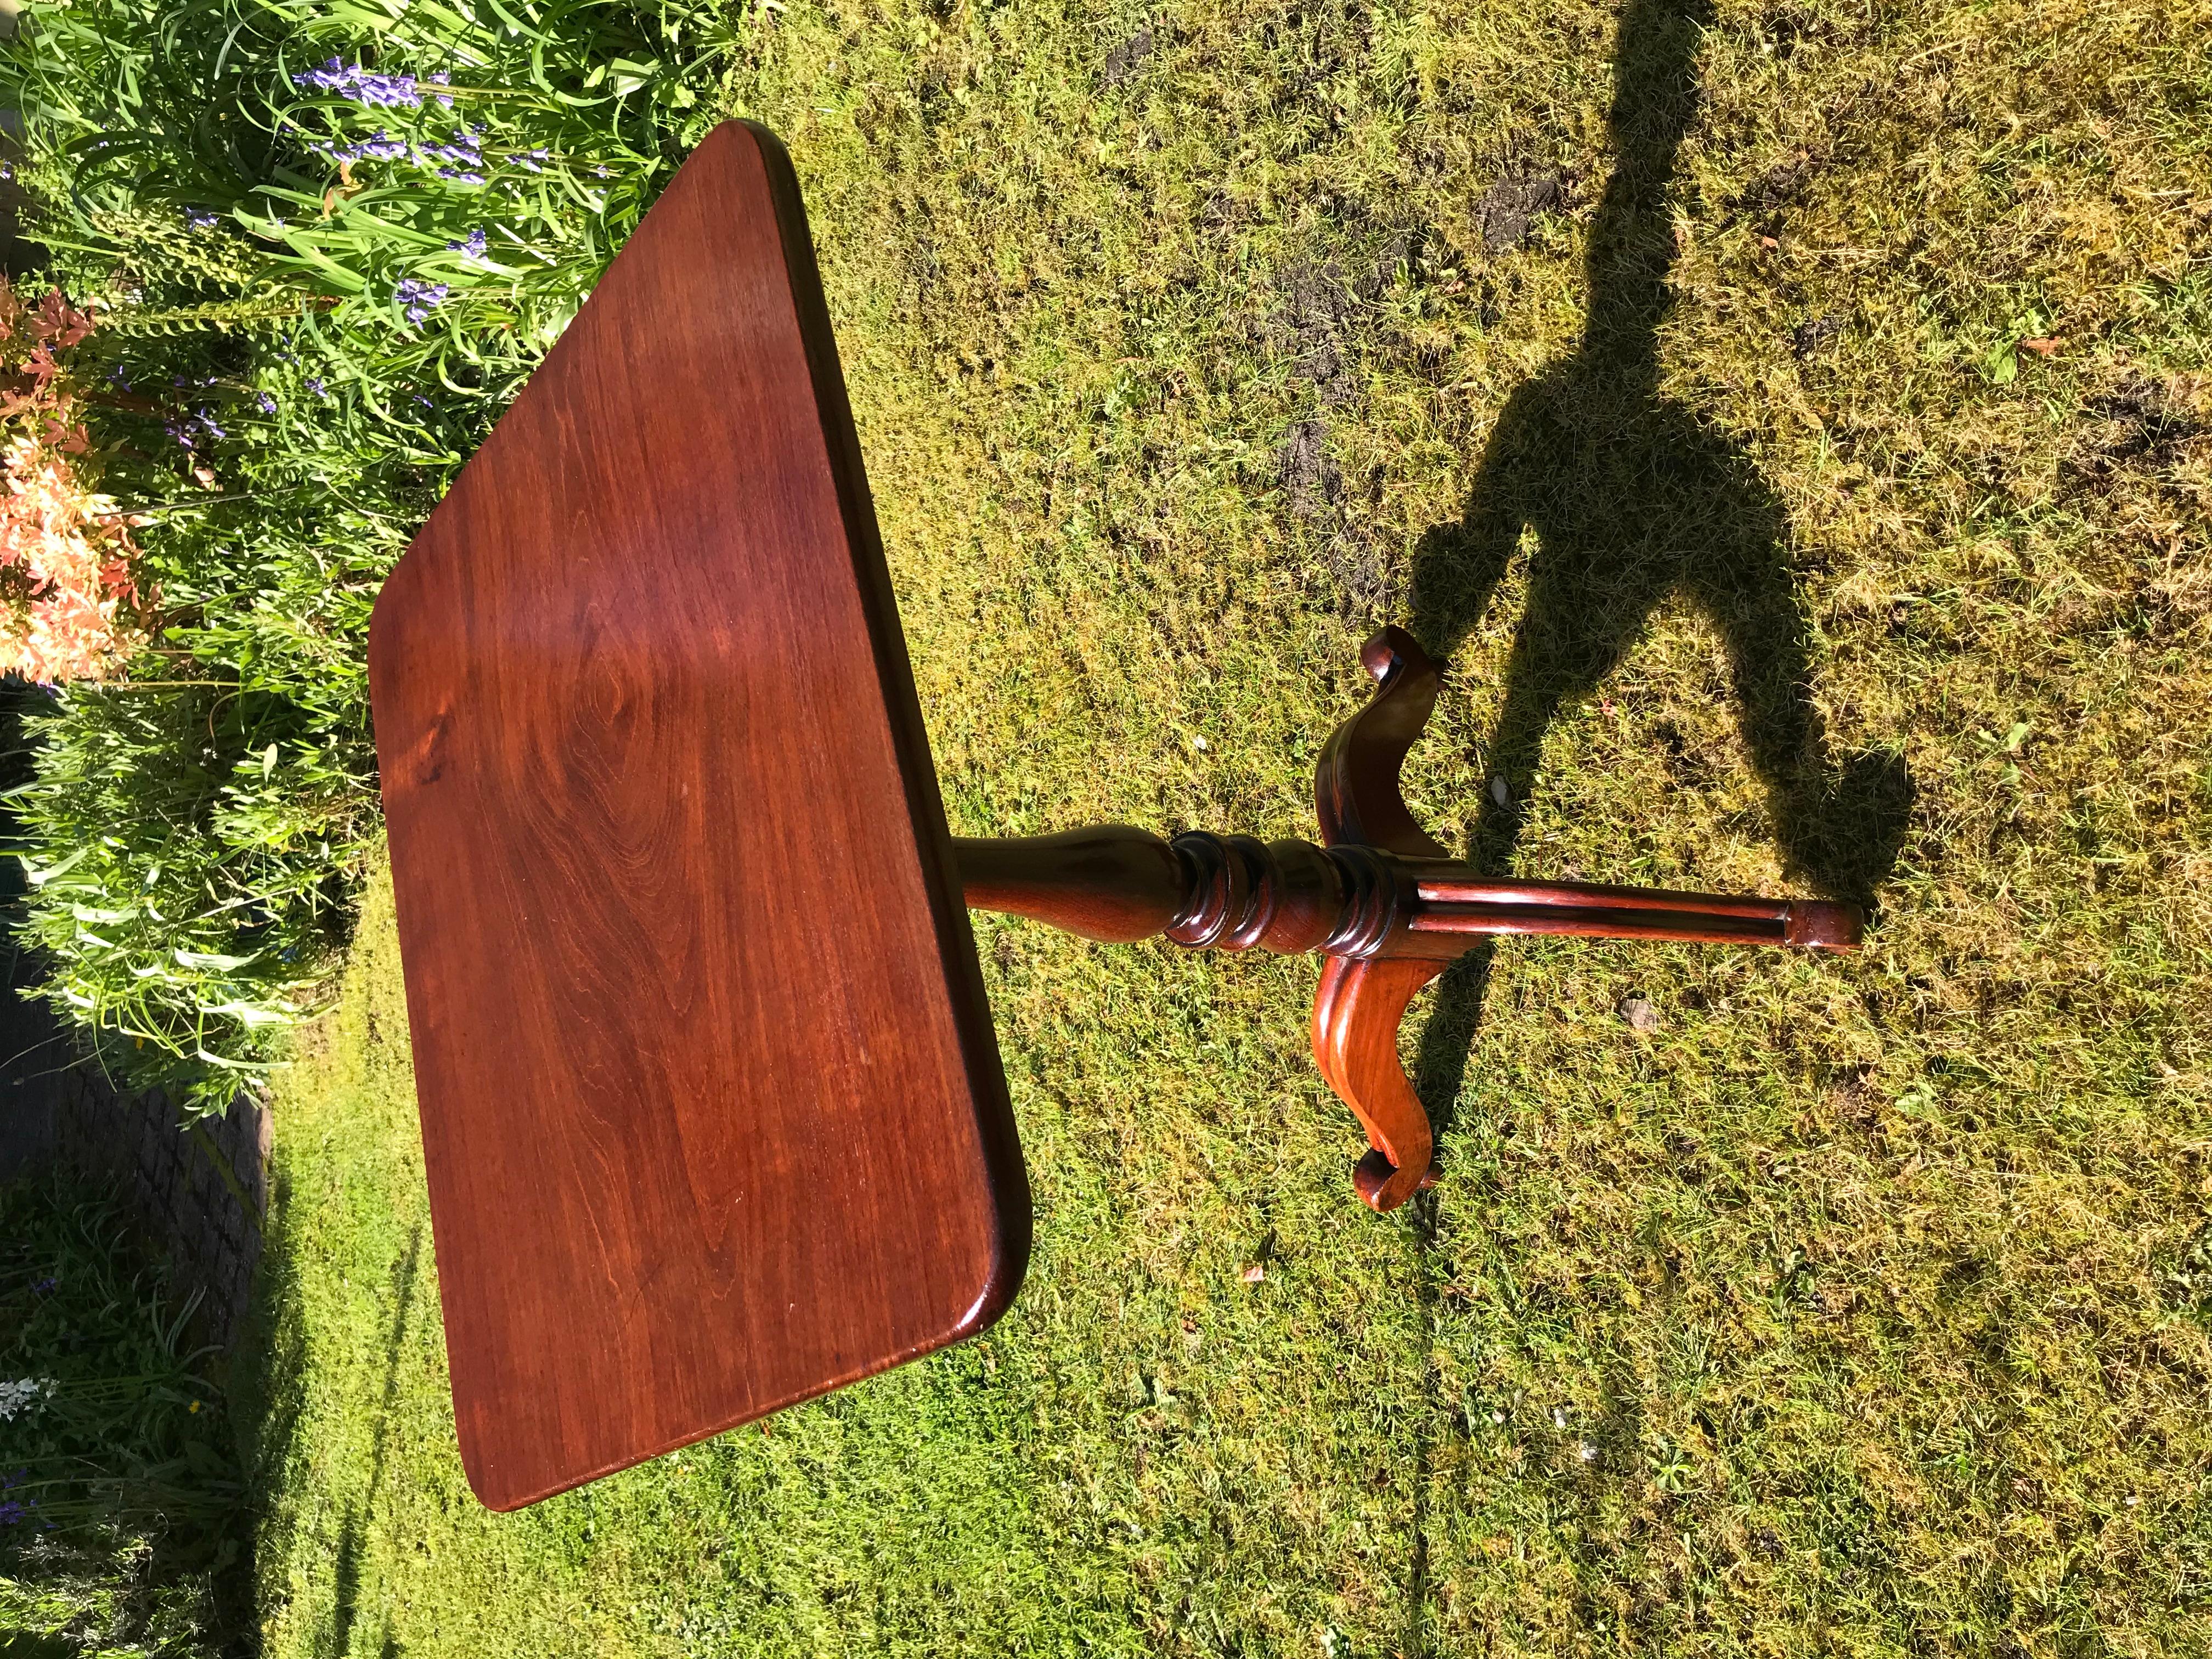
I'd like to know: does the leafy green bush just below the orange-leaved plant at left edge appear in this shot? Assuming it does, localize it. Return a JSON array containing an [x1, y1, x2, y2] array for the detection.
[[15, 681, 376, 1108]]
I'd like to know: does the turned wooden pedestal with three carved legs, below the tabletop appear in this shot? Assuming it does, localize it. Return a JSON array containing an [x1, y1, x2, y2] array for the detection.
[[956, 628, 1863, 1210]]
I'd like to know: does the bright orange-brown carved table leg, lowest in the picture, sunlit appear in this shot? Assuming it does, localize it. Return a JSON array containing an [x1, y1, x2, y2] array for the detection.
[[1314, 956, 1449, 1210]]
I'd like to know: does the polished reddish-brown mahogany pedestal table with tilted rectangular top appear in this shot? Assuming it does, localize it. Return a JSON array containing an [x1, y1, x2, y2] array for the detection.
[[369, 124, 1858, 1509]]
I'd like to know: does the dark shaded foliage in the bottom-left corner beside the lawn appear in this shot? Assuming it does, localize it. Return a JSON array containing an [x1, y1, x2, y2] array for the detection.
[[0, 1179, 244, 1657]]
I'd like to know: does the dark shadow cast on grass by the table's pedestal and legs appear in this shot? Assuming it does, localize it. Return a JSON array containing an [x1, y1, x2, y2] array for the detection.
[[1411, 0, 1914, 1124]]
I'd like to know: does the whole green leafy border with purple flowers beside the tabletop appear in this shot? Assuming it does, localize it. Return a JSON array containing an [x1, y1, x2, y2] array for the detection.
[[0, 0, 743, 1110]]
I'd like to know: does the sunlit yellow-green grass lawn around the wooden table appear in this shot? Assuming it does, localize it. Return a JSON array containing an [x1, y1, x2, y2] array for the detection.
[[241, 0, 2212, 1659]]
